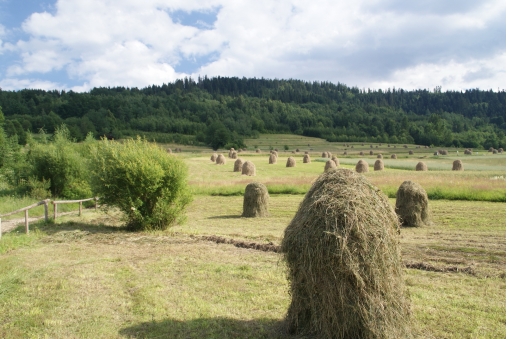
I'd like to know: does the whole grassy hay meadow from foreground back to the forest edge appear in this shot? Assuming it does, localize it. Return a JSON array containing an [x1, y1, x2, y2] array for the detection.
[[0, 135, 506, 338]]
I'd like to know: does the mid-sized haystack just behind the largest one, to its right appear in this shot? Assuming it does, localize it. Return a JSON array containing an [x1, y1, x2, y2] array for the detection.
[[395, 181, 431, 227]]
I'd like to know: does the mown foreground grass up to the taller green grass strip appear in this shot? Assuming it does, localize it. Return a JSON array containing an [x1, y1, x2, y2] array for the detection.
[[0, 195, 506, 338]]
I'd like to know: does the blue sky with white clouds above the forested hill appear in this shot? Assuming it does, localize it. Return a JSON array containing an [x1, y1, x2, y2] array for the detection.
[[0, 0, 506, 91]]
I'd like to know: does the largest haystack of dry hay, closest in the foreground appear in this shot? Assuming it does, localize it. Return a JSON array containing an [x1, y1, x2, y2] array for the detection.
[[281, 169, 411, 338]]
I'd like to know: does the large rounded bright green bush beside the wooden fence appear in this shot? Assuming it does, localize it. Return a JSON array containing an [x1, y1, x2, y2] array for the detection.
[[92, 137, 191, 230]]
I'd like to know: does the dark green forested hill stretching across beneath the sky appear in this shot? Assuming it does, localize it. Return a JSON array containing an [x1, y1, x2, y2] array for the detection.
[[0, 77, 506, 148]]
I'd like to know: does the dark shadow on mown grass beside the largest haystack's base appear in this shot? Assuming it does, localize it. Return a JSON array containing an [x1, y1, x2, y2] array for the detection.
[[119, 318, 294, 339]]
